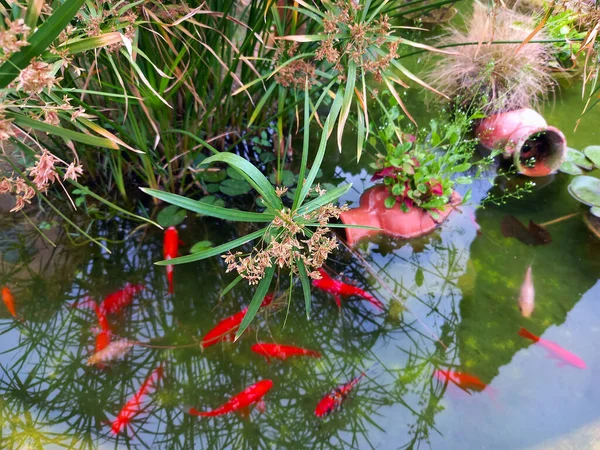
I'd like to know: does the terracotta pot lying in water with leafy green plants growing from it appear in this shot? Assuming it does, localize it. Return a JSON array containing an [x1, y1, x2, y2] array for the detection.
[[340, 185, 461, 245]]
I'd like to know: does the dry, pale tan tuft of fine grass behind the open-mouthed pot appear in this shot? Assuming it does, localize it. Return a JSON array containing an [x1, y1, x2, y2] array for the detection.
[[428, 3, 554, 114]]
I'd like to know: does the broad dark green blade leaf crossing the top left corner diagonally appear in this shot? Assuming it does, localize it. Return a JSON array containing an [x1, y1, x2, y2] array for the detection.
[[0, 0, 84, 89]]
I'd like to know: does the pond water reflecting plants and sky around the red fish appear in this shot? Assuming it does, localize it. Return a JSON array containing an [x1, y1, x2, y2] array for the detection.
[[0, 86, 600, 450]]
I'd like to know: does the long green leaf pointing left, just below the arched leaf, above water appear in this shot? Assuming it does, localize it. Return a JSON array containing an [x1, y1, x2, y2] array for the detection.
[[140, 188, 275, 222]]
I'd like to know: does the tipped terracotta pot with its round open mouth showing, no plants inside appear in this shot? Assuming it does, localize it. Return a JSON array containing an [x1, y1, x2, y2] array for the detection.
[[475, 108, 567, 177]]
